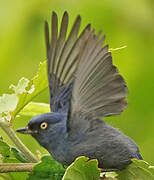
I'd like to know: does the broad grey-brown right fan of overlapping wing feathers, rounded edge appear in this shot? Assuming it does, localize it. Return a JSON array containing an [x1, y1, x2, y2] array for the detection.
[[69, 29, 128, 127]]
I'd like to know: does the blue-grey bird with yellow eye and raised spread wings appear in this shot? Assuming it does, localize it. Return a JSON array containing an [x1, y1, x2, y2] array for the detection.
[[16, 11, 142, 172]]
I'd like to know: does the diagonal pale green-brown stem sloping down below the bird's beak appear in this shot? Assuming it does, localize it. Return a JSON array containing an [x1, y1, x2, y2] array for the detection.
[[0, 119, 39, 163]]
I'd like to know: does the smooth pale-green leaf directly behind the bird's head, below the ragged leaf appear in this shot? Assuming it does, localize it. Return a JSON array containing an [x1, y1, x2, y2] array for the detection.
[[19, 102, 50, 116]]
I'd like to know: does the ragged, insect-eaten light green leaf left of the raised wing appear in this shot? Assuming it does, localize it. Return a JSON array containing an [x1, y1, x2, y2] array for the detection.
[[0, 61, 48, 124]]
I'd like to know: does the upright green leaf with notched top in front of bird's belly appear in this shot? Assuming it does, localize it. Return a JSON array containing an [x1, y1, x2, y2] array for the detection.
[[62, 156, 100, 180]]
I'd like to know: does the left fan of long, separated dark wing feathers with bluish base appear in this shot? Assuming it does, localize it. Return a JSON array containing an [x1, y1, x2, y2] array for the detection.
[[45, 12, 90, 111]]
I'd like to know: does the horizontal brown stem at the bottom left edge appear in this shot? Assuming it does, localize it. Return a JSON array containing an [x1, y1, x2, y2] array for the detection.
[[0, 163, 36, 173]]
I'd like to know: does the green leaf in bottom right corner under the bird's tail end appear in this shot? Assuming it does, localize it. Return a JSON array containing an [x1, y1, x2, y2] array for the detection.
[[118, 159, 154, 180]]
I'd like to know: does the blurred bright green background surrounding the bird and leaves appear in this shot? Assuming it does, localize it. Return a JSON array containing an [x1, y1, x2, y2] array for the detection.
[[0, 0, 154, 165]]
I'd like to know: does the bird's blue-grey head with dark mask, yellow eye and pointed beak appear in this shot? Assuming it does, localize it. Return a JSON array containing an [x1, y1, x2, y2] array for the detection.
[[16, 113, 66, 149]]
